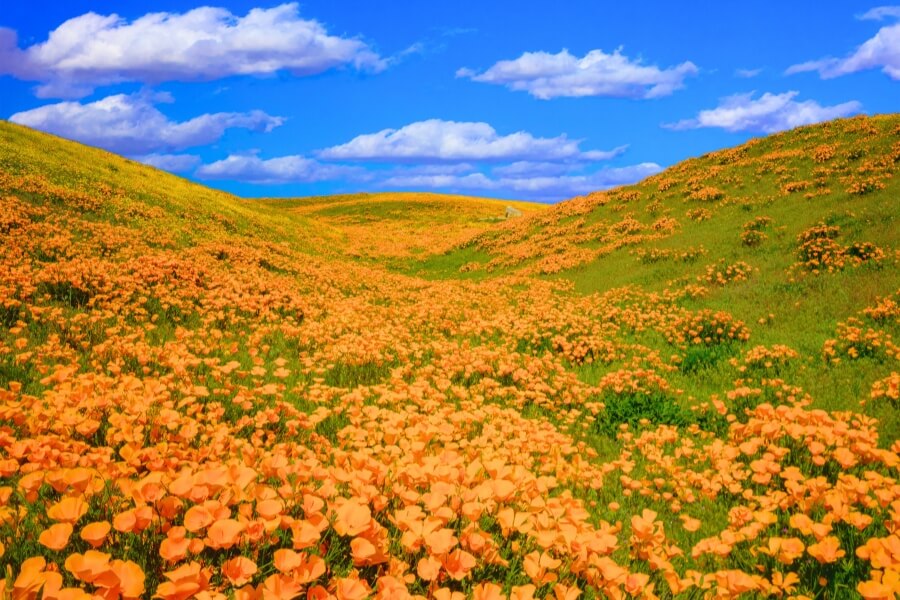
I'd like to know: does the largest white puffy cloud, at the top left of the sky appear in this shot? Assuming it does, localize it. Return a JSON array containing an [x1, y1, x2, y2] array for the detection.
[[0, 3, 387, 98]]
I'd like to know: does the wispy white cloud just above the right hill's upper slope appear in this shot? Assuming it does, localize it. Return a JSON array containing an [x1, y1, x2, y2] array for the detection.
[[665, 92, 862, 133]]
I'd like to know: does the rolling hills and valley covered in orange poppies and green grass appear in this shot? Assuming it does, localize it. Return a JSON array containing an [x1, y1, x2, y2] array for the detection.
[[0, 115, 900, 600]]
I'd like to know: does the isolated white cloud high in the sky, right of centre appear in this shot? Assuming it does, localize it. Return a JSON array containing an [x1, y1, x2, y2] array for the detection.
[[456, 49, 698, 100]]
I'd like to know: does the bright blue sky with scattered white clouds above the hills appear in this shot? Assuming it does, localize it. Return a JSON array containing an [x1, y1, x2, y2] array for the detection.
[[0, 0, 900, 202]]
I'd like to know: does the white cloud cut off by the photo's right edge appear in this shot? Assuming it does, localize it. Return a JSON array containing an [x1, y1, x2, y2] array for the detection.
[[786, 6, 900, 80]]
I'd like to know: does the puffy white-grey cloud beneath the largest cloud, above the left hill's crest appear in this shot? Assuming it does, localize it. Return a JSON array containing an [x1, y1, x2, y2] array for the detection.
[[9, 94, 283, 154]]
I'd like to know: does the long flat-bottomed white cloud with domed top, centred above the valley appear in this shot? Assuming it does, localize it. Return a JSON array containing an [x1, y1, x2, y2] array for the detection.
[[319, 119, 624, 161]]
